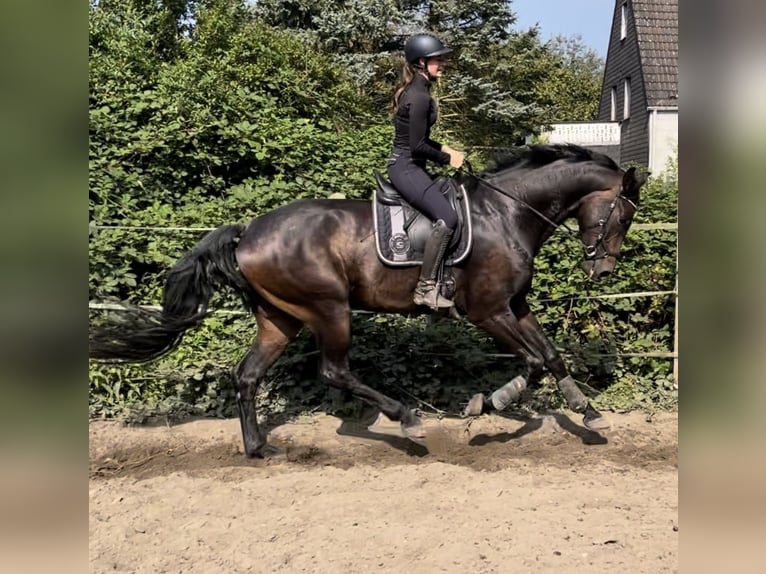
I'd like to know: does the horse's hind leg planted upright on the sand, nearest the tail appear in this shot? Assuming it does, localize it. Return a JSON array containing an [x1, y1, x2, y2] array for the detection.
[[235, 303, 303, 458]]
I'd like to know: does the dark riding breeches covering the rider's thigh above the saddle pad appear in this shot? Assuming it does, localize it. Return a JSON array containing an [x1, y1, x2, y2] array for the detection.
[[388, 153, 457, 230]]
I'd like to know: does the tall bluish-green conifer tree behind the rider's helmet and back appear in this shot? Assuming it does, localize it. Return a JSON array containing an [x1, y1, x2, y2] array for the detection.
[[256, 0, 537, 145]]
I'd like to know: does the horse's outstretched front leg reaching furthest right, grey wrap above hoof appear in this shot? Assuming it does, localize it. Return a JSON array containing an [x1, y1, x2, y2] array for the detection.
[[511, 298, 607, 430]]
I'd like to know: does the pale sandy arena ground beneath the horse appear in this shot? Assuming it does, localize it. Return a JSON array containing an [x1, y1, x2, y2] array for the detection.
[[90, 413, 678, 574]]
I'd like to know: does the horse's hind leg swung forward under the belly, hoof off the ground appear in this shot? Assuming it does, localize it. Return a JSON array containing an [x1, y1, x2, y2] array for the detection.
[[308, 306, 424, 440]]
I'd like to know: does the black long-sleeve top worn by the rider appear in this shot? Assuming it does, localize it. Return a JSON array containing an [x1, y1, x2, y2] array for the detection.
[[394, 74, 450, 165]]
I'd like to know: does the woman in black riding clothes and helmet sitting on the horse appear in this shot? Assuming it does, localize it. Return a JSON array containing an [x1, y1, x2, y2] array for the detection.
[[388, 33, 464, 309]]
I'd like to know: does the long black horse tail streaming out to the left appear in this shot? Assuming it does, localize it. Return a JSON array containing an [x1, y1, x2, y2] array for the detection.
[[88, 225, 257, 361]]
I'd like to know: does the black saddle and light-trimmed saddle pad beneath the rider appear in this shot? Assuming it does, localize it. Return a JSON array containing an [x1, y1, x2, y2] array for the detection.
[[372, 168, 473, 267]]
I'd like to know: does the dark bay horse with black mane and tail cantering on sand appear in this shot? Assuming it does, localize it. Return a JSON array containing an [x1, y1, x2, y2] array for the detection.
[[90, 145, 646, 457]]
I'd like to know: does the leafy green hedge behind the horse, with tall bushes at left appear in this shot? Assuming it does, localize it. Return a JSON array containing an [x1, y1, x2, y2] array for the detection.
[[89, 3, 677, 420]]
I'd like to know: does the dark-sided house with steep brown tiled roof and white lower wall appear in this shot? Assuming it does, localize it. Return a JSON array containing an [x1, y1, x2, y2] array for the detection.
[[598, 0, 678, 174]]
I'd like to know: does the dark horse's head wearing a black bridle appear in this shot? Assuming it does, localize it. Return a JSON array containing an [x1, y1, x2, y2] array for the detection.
[[577, 167, 648, 281]]
